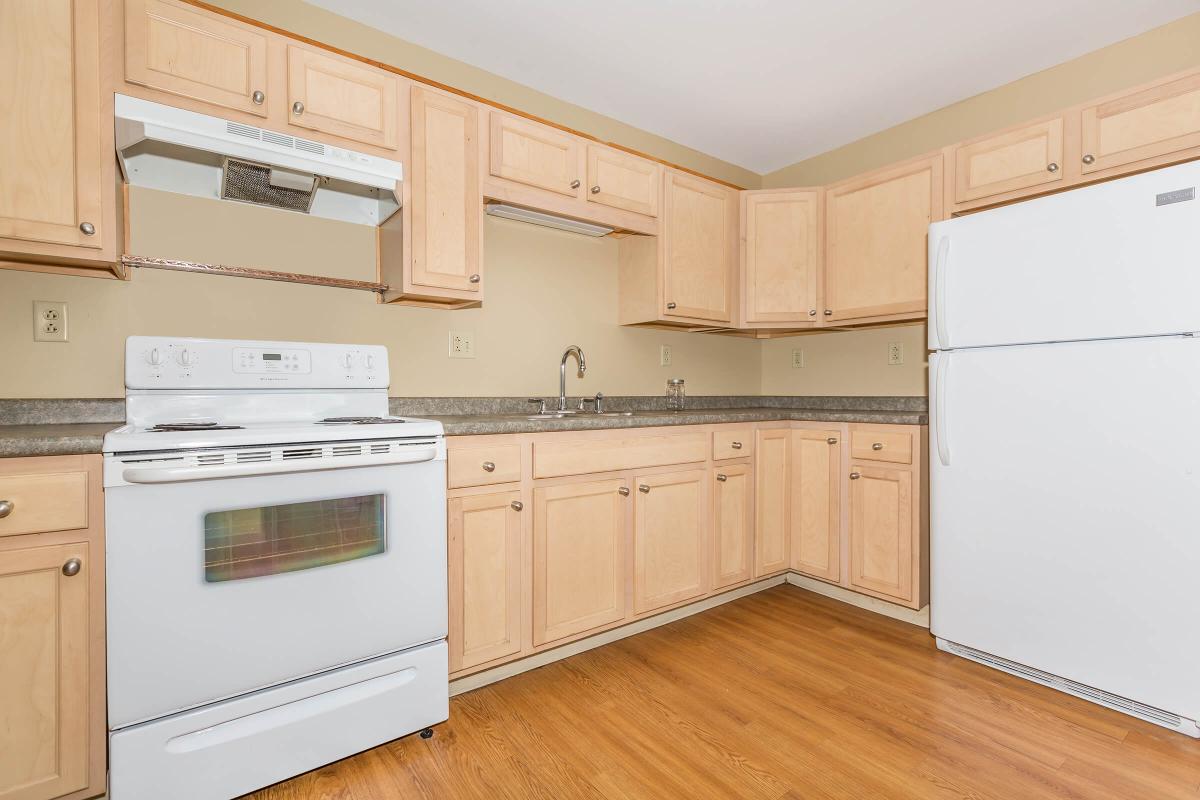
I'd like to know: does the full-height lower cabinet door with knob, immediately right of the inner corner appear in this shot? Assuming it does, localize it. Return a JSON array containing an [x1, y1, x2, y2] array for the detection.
[[792, 429, 841, 582]]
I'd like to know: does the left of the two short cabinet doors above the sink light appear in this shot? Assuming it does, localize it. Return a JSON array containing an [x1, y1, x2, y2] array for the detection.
[[488, 112, 581, 197]]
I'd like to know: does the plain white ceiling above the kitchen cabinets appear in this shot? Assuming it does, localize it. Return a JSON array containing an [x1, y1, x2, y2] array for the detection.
[[308, 0, 1200, 173]]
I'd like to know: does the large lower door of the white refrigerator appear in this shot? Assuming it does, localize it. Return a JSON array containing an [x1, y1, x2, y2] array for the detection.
[[929, 336, 1200, 720]]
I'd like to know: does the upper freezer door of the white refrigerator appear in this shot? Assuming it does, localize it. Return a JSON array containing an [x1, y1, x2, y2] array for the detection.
[[929, 162, 1200, 350]]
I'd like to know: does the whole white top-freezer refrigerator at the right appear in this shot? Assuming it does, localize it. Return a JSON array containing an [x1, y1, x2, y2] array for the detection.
[[929, 162, 1200, 736]]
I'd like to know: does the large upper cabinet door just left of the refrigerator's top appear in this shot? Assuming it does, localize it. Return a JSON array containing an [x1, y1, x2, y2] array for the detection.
[[822, 155, 943, 321]]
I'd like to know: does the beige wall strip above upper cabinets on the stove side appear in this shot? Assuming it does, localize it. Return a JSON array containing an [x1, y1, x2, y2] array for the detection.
[[201, 0, 762, 188]]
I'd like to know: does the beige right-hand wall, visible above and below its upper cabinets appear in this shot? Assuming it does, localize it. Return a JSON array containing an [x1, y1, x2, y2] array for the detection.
[[762, 14, 1200, 395]]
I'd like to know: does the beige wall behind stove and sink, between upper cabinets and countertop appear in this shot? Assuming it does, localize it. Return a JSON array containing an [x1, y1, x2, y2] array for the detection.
[[0, 190, 761, 397]]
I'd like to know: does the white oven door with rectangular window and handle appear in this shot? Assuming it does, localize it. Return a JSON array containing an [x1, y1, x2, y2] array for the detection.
[[106, 440, 446, 728]]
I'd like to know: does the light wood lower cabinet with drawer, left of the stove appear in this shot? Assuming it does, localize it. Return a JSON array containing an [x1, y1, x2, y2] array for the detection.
[[0, 456, 107, 800]]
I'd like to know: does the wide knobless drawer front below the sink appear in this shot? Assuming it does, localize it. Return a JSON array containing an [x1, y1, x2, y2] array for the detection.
[[533, 433, 708, 477]]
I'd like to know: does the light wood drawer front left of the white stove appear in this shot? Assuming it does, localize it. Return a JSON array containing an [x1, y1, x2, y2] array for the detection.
[[0, 471, 88, 536]]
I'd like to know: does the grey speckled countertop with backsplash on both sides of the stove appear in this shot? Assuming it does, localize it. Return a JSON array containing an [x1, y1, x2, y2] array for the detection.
[[0, 397, 928, 457]]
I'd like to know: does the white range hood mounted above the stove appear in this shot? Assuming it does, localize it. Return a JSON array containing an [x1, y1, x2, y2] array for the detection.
[[115, 95, 404, 225]]
